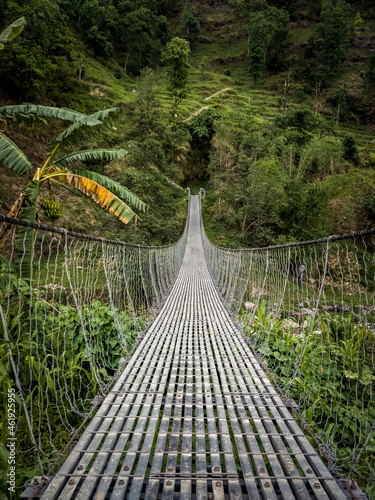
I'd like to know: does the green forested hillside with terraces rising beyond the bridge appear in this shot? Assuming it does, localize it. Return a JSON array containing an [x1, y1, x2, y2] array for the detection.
[[0, 0, 375, 246]]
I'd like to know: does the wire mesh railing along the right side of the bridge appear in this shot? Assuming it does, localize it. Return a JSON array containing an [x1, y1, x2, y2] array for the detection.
[[202, 194, 375, 497]]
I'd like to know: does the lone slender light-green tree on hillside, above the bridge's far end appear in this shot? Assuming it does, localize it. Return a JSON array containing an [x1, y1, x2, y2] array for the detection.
[[163, 37, 190, 109]]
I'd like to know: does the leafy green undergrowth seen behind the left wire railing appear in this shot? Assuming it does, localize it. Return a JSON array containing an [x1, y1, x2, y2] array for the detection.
[[0, 266, 142, 498]]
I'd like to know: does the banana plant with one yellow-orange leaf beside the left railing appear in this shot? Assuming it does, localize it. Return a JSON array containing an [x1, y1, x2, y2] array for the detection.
[[0, 104, 146, 278]]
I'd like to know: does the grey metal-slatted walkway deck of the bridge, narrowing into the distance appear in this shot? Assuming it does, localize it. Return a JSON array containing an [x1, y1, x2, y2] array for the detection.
[[42, 197, 346, 500]]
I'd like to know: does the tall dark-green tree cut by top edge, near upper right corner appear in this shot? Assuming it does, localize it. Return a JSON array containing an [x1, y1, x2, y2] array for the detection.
[[318, 0, 350, 71]]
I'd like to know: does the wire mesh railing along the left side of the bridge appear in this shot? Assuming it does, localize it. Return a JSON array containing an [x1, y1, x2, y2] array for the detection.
[[0, 202, 188, 495]]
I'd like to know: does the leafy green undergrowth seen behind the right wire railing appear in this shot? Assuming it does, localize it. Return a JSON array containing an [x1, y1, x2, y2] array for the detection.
[[245, 305, 375, 498]]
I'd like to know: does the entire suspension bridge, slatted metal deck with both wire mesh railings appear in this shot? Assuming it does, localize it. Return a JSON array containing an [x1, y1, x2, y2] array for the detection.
[[0, 196, 373, 500]]
